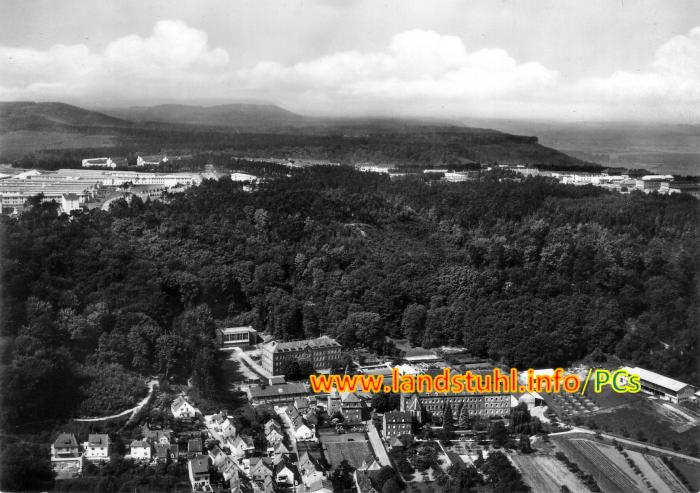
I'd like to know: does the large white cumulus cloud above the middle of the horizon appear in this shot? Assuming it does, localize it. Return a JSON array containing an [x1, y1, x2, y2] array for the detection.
[[238, 30, 559, 102]]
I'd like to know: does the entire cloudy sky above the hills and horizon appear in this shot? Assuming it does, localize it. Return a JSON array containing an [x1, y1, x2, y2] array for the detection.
[[0, 0, 700, 123]]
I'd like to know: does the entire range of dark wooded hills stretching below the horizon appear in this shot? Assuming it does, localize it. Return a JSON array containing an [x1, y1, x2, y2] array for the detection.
[[0, 102, 590, 169]]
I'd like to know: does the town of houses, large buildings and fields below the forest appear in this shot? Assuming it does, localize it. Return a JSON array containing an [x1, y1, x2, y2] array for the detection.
[[46, 326, 700, 493]]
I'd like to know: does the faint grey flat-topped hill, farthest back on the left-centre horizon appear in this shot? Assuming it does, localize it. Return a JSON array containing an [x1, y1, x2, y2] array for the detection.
[[106, 103, 304, 128]]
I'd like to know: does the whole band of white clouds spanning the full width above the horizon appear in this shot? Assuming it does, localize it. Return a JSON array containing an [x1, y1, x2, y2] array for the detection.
[[0, 20, 700, 122]]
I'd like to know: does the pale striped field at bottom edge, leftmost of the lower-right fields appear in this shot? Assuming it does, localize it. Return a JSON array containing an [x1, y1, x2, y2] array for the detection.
[[509, 454, 589, 493]]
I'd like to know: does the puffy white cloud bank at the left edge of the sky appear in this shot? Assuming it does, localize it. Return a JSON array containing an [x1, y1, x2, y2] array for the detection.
[[0, 20, 229, 99]]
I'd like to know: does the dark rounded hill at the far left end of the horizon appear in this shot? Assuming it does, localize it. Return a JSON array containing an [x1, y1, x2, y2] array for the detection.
[[0, 101, 131, 131]]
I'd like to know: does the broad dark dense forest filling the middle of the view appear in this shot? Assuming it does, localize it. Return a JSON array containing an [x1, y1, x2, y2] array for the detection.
[[0, 167, 700, 429]]
